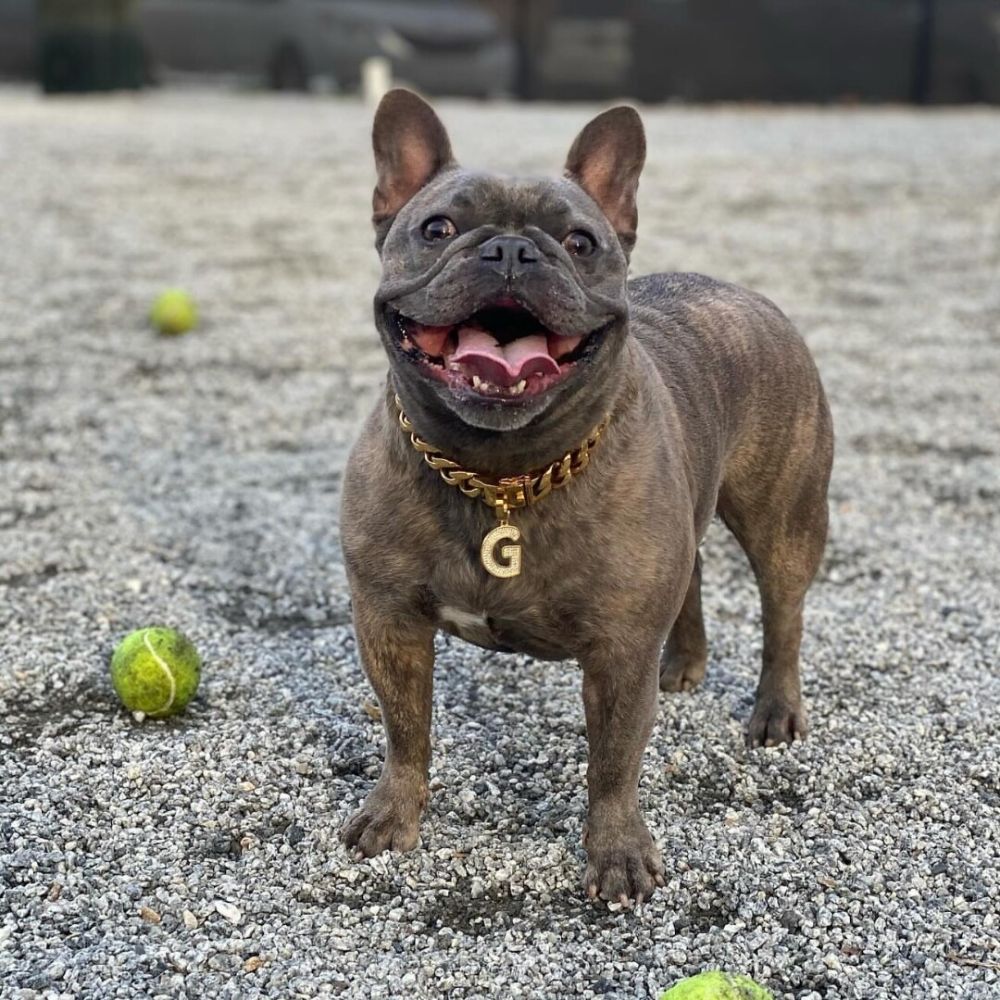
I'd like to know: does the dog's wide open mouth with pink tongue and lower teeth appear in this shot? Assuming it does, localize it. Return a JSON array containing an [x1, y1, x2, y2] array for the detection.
[[396, 301, 605, 401]]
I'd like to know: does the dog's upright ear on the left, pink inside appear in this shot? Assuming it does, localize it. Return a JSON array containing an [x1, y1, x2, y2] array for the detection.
[[372, 90, 455, 237]]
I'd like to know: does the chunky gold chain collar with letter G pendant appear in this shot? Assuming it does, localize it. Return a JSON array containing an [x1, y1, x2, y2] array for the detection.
[[394, 396, 608, 578]]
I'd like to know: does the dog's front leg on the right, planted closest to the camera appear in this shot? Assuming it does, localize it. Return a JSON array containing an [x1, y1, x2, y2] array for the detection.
[[581, 641, 664, 905]]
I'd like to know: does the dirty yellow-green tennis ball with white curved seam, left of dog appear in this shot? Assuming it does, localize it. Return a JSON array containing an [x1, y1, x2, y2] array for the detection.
[[111, 628, 201, 719]]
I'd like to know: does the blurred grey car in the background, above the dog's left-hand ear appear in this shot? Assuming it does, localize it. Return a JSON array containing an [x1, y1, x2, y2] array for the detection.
[[139, 0, 514, 97]]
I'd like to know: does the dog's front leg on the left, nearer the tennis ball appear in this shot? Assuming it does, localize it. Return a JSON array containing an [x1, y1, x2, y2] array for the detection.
[[342, 591, 434, 858]]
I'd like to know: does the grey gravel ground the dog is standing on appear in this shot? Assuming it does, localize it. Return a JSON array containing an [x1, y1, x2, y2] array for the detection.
[[0, 90, 1000, 1000]]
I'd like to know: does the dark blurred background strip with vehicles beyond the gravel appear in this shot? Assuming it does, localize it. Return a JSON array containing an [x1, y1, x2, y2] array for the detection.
[[0, 0, 1000, 103]]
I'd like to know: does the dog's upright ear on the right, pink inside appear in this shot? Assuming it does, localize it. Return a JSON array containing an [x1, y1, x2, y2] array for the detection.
[[566, 106, 646, 254]]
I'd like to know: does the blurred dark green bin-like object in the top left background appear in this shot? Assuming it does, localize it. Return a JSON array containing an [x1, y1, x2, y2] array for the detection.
[[38, 0, 146, 94]]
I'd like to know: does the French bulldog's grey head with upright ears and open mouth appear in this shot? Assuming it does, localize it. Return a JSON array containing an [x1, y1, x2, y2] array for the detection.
[[373, 90, 645, 431]]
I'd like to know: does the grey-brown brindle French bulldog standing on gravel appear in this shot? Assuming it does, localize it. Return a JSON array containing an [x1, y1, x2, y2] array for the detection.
[[342, 90, 833, 904]]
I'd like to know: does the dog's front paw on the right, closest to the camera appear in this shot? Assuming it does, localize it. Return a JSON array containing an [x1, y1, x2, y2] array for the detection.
[[583, 813, 664, 906]]
